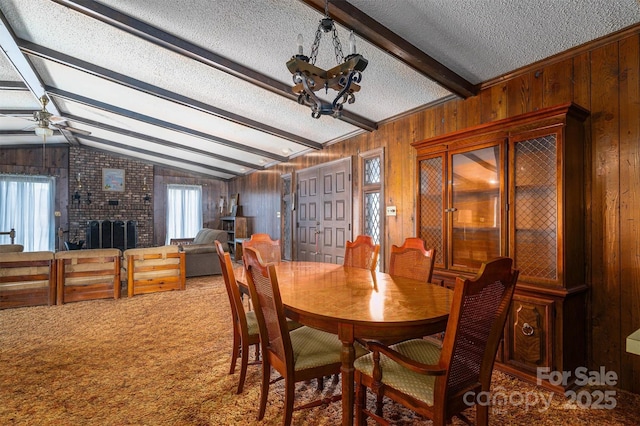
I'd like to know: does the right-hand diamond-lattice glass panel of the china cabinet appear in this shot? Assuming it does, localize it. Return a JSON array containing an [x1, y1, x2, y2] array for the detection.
[[514, 134, 558, 280]]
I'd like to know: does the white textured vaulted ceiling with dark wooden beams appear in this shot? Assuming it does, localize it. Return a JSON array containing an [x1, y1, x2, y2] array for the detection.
[[0, 0, 640, 180]]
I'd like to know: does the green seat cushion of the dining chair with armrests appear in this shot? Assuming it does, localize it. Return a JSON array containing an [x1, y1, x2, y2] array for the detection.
[[353, 339, 441, 405]]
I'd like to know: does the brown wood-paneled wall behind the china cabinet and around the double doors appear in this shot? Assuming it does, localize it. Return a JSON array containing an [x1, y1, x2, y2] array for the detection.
[[229, 26, 640, 393]]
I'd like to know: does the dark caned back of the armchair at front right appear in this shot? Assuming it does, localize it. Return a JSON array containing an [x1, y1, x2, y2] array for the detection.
[[434, 257, 518, 406]]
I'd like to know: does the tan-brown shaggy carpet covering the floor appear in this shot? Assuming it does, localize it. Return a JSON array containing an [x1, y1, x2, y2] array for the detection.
[[0, 277, 640, 426]]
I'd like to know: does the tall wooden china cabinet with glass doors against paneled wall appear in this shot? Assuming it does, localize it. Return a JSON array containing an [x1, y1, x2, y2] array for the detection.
[[412, 104, 589, 390]]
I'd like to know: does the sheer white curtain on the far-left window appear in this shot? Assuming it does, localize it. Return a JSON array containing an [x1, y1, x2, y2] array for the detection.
[[0, 175, 55, 251]]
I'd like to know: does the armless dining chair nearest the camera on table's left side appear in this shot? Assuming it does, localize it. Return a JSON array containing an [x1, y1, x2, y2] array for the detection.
[[242, 248, 366, 426]]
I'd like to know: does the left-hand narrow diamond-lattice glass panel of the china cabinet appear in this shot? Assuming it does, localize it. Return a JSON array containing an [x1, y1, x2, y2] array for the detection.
[[419, 157, 444, 265]]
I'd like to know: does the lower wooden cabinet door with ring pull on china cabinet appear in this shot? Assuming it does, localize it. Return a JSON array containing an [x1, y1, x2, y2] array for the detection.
[[503, 294, 554, 373]]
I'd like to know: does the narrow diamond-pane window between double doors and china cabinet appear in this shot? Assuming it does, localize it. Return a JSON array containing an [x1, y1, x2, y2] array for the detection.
[[360, 149, 384, 271]]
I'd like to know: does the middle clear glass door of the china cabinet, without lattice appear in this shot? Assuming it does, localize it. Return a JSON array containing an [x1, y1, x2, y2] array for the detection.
[[446, 143, 505, 271]]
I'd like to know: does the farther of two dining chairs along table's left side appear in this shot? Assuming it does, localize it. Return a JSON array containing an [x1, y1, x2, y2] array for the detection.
[[214, 240, 260, 393]]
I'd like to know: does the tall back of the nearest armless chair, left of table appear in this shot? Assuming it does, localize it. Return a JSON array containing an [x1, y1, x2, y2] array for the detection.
[[242, 247, 294, 373]]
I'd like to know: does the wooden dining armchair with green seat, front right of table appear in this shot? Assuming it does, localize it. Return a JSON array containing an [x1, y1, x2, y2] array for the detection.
[[354, 257, 519, 425]]
